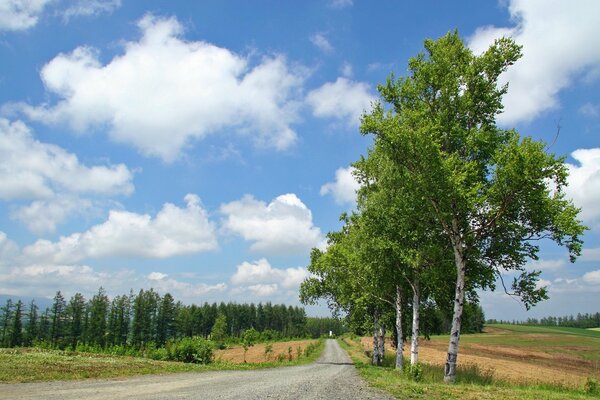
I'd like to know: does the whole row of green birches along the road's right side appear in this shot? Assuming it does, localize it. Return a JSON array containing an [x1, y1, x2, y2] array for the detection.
[[300, 31, 586, 383]]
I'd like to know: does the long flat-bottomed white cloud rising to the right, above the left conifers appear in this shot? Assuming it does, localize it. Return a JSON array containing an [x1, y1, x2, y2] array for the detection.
[[23, 194, 218, 264]]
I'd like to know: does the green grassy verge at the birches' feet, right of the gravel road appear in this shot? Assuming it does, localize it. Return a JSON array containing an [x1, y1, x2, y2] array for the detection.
[[340, 338, 597, 400]]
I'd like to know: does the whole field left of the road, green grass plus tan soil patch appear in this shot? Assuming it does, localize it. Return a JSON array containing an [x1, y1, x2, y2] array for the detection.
[[0, 340, 323, 383]]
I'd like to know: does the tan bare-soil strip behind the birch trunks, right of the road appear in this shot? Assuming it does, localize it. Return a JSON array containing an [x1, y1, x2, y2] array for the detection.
[[361, 337, 600, 387]]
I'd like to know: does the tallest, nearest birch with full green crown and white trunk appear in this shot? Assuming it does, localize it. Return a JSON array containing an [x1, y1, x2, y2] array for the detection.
[[361, 32, 585, 382]]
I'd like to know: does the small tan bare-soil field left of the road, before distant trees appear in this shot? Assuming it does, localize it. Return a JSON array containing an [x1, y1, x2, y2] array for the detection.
[[215, 340, 318, 364]]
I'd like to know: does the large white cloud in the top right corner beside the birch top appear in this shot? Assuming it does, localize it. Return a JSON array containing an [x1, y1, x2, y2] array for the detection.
[[469, 0, 600, 124]]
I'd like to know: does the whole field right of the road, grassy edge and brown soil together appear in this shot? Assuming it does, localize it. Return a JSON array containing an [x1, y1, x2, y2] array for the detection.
[[346, 325, 600, 399]]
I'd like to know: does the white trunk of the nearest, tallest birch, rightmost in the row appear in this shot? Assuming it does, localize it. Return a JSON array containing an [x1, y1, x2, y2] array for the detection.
[[444, 220, 466, 383]]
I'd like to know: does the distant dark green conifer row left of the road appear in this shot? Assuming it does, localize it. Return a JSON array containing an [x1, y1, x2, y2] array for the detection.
[[0, 288, 343, 349]]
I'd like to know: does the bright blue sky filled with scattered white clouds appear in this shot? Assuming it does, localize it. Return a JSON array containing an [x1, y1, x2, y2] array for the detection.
[[0, 0, 600, 319]]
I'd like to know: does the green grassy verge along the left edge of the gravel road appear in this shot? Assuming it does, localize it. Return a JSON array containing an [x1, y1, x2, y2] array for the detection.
[[0, 340, 324, 383]]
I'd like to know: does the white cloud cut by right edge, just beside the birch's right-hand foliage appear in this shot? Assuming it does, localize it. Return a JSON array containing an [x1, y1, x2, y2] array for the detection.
[[565, 148, 600, 227]]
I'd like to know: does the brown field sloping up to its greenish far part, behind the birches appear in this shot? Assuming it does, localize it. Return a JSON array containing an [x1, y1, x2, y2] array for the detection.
[[362, 328, 600, 387]]
